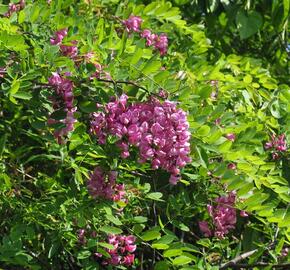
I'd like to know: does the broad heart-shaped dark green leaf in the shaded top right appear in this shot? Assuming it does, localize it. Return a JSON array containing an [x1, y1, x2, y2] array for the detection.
[[236, 10, 263, 39]]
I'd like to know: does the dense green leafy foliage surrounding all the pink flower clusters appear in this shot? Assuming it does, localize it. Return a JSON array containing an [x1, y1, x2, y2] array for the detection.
[[0, 0, 290, 270]]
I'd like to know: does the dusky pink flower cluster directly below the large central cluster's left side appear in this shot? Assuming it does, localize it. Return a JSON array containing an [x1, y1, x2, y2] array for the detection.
[[87, 167, 127, 203]]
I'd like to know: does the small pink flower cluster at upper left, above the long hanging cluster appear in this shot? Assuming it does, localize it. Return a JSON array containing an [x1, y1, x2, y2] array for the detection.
[[50, 28, 78, 58]]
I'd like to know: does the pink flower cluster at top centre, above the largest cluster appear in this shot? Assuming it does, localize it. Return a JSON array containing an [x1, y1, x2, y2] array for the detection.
[[123, 15, 168, 55]]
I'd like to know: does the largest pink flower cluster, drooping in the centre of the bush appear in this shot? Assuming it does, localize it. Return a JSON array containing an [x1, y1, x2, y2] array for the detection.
[[91, 94, 191, 184]]
